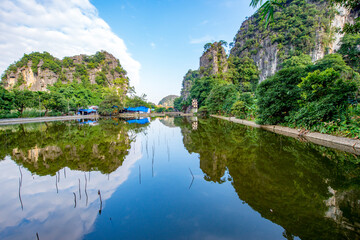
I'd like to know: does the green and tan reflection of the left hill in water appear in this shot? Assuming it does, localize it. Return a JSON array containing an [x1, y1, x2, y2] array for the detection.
[[0, 120, 147, 175]]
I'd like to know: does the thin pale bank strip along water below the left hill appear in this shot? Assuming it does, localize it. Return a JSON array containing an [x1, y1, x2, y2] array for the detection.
[[0, 115, 100, 125]]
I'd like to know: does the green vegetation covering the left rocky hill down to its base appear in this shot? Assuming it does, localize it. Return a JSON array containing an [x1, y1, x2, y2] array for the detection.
[[0, 52, 129, 118]]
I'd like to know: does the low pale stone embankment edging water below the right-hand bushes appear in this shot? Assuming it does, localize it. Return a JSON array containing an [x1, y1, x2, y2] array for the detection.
[[211, 115, 360, 155]]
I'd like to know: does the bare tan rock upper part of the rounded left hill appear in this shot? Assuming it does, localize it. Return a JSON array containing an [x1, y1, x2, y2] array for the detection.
[[2, 51, 127, 91]]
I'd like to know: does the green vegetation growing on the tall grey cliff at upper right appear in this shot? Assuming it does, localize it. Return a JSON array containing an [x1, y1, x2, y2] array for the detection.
[[231, 0, 335, 62]]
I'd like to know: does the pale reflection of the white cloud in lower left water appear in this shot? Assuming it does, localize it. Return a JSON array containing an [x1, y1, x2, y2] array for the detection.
[[0, 141, 141, 240]]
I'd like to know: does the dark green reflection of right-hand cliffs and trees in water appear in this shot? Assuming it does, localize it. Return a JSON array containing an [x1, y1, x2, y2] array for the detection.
[[176, 119, 360, 239]]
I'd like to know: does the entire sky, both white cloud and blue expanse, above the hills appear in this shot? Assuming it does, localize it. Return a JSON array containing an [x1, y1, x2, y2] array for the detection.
[[0, 0, 255, 104]]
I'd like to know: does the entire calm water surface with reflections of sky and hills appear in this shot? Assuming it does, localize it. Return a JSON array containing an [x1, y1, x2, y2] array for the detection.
[[0, 118, 360, 240]]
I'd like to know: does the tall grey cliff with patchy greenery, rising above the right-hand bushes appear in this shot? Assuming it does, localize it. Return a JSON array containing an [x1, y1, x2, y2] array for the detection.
[[230, 0, 356, 81]]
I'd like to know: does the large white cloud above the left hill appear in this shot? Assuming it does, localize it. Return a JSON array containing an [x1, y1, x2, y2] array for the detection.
[[0, 0, 141, 86]]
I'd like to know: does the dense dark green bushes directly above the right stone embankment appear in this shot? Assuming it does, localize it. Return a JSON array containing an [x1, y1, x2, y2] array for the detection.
[[257, 54, 360, 136]]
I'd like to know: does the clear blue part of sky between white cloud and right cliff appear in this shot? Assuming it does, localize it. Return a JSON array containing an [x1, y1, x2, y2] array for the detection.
[[91, 0, 254, 103]]
